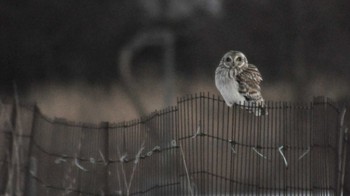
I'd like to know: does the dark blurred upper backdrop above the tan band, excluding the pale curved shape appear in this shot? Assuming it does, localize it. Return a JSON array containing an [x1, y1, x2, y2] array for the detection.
[[0, 0, 350, 100]]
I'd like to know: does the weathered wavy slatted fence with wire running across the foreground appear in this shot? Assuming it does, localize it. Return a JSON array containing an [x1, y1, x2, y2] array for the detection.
[[0, 93, 349, 195]]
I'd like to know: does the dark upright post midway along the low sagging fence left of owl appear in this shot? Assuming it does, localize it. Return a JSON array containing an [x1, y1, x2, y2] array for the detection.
[[101, 122, 110, 195]]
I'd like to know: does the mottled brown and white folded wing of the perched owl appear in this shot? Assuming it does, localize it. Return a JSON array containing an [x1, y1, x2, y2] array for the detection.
[[237, 64, 263, 102]]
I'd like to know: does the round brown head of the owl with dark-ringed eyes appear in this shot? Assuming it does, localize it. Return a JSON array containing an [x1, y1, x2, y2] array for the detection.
[[220, 50, 248, 70]]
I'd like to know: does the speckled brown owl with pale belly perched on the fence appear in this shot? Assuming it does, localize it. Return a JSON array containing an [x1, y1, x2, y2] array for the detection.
[[215, 50, 267, 116]]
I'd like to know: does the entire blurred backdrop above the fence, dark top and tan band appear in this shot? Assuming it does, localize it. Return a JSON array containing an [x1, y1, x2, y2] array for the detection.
[[0, 0, 350, 122]]
